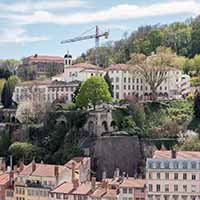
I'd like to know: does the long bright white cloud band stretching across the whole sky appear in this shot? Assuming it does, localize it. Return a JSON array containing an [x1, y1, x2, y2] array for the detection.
[[0, 0, 200, 25]]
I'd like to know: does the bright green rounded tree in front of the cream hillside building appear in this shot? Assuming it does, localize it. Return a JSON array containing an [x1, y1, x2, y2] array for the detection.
[[76, 76, 112, 110]]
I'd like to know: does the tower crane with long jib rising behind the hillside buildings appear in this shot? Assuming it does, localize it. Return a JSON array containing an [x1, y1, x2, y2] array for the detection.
[[61, 26, 109, 65]]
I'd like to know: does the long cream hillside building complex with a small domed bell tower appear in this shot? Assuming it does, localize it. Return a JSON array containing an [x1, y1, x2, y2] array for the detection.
[[13, 54, 190, 103]]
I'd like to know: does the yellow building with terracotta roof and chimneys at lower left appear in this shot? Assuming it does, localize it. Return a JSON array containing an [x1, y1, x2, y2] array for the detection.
[[14, 161, 72, 200]]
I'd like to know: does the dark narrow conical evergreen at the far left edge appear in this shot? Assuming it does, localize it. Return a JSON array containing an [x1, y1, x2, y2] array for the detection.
[[1, 82, 12, 108]]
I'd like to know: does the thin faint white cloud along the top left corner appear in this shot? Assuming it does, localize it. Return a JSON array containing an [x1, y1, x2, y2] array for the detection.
[[0, 0, 88, 13]]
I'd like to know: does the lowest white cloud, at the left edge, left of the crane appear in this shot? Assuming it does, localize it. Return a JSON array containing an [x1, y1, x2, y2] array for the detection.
[[0, 27, 49, 43]]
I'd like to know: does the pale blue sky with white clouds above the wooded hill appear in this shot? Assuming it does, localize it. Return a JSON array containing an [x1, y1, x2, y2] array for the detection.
[[0, 0, 200, 59]]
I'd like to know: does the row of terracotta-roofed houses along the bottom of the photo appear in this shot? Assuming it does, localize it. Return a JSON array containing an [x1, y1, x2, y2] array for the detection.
[[0, 150, 200, 200]]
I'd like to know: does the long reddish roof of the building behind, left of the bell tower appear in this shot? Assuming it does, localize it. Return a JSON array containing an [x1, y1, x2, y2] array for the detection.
[[27, 55, 64, 63]]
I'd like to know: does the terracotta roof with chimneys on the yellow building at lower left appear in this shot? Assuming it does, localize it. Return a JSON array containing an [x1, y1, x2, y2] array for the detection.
[[20, 163, 66, 177]]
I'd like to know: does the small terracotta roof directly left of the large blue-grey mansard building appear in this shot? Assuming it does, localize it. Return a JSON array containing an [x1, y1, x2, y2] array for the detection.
[[120, 177, 145, 188]]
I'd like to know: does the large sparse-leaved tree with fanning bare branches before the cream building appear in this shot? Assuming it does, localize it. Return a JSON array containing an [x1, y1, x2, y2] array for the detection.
[[128, 47, 176, 100]]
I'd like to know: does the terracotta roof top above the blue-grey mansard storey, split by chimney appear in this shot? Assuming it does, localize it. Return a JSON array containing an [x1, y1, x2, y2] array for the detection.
[[153, 151, 200, 160]]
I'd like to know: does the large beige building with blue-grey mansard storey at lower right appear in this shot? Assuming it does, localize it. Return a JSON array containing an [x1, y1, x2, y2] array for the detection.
[[146, 150, 200, 200]]
